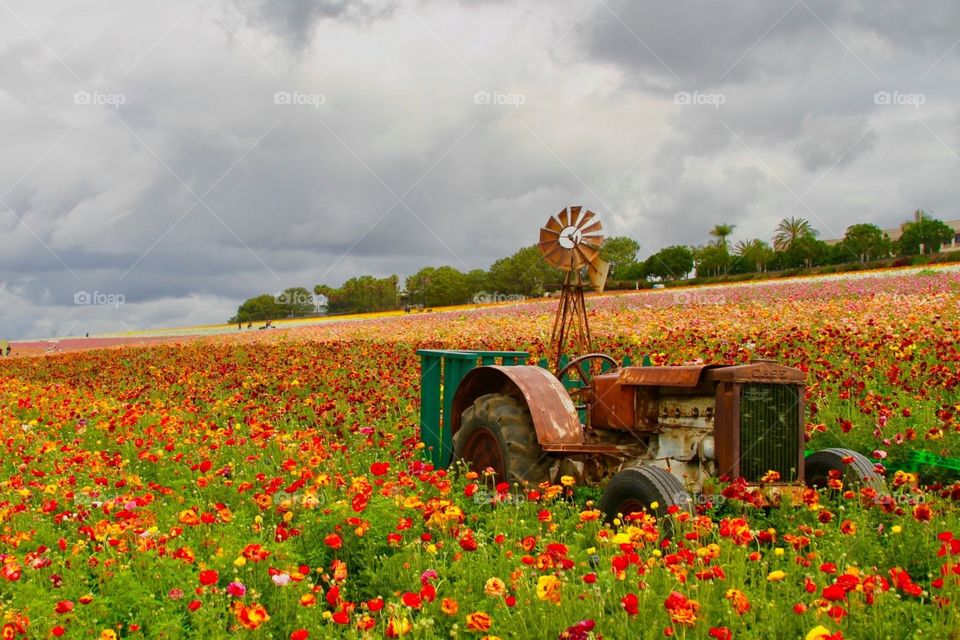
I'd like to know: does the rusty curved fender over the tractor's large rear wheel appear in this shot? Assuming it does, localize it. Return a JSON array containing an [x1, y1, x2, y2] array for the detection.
[[450, 365, 584, 445]]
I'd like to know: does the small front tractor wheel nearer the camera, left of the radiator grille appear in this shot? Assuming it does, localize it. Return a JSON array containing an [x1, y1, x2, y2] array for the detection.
[[600, 465, 693, 537]]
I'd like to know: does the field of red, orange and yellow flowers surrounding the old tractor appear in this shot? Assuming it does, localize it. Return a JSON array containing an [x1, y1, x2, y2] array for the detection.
[[0, 271, 960, 639]]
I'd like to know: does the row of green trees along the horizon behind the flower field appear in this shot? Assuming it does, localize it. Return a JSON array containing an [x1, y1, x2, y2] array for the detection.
[[225, 211, 954, 323]]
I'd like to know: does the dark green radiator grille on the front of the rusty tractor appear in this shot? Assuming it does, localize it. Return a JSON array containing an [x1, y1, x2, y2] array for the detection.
[[740, 384, 800, 482]]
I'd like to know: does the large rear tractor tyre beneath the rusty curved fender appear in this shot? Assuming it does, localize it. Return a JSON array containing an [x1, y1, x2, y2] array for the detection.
[[453, 393, 551, 485]]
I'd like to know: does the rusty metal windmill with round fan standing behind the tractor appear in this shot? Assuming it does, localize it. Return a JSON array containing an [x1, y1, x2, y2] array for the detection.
[[539, 207, 610, 370]]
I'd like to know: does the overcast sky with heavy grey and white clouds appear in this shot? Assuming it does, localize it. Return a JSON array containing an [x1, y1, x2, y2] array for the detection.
[[0, 0, 960, 338]]
